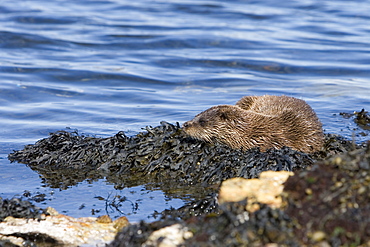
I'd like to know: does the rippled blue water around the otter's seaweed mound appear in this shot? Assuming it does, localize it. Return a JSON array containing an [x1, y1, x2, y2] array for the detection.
[[0, 0, 370, 221]]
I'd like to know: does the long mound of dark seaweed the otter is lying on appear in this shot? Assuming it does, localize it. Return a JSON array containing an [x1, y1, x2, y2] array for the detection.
[[9, 122, 313, 188]]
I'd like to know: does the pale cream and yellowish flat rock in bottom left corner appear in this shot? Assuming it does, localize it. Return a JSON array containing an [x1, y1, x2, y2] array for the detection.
[[0, 208, 128, 246]]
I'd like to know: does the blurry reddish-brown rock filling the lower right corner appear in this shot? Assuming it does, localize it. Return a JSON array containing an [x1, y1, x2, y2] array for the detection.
[[285, 142, 370, 246]]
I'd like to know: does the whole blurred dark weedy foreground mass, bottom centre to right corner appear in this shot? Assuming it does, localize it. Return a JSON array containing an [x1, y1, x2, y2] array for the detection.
[[110, 142, 370, 247]]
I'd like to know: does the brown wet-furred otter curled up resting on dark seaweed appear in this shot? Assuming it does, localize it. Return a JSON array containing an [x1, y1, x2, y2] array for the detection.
[[183, 95, 324, 153]]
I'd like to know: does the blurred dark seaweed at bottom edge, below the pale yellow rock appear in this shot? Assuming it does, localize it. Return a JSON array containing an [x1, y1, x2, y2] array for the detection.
[[109, 201, 298, 247]]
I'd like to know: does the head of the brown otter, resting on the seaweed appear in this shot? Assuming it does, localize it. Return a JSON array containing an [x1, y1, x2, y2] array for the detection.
[[183, 105, 244, 145]]
